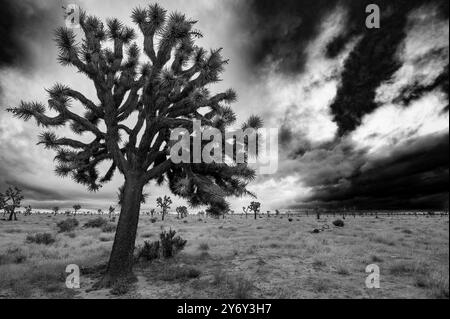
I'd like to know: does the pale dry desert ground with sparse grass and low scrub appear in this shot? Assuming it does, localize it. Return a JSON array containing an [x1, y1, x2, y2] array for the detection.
[[0, 215, 449, 299]]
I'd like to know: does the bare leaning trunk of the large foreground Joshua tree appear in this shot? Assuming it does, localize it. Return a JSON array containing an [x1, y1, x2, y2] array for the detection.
[[96, 175, 144, 288]]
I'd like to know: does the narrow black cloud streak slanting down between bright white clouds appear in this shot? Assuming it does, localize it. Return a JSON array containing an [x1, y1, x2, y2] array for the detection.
[[331, 0, 447, 135]]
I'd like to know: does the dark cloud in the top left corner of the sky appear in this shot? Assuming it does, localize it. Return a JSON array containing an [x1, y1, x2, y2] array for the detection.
[[0, 0, 62, 68]]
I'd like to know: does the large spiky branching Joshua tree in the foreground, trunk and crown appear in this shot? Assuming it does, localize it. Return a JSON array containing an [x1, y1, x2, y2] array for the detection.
[[8, 4, 262, 287]]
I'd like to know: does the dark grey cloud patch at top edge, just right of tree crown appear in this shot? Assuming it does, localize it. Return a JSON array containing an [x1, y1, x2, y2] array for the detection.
[[239, 0, 337, 74]]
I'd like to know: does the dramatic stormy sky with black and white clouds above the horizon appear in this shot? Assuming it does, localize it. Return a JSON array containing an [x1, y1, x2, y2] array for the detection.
[[0, 0, 449, 211]]
